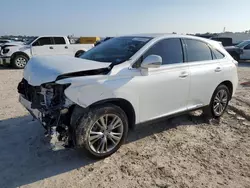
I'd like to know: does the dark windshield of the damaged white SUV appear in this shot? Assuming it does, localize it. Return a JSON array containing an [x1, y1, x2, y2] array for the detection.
[[80, 37, 152, 65]]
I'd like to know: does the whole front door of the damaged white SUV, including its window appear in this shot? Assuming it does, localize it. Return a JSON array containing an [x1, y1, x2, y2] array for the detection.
[[136, 38, 190, 122]]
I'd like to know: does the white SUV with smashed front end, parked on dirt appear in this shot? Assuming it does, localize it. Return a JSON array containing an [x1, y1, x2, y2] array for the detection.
[[18, 34, 238, 158]]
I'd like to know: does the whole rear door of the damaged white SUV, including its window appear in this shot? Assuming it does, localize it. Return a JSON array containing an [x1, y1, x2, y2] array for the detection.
[[184, 39, 222, 109]]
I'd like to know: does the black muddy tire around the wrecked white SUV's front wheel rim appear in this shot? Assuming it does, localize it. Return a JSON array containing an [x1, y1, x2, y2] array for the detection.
[[75, 104, 128, 158]]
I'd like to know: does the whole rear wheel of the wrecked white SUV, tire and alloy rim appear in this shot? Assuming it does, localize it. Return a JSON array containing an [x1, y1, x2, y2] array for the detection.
[[204, 85, 230, 118]]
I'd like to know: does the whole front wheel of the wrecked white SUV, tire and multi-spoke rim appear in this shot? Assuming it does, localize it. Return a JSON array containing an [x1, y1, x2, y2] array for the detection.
[[76, 104, 128, 158]]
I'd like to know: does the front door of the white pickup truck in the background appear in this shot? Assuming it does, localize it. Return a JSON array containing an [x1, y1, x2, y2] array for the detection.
[[31, 37, 55, 56]]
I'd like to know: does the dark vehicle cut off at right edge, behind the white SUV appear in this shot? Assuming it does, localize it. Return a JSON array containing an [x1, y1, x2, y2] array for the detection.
[[225, 40, 250, 61]]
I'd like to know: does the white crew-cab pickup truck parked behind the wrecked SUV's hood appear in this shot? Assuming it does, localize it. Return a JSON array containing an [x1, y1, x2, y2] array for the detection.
[[0, 36, 94, 69]]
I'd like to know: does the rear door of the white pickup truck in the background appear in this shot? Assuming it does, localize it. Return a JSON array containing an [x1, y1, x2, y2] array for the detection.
[[53, 37, 73, 56]]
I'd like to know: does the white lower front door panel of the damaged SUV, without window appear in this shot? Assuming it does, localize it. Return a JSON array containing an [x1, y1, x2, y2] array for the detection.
[[138, 63, 190, 121]]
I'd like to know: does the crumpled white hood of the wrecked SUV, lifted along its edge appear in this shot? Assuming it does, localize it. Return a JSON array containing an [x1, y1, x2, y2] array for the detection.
[[23, 56, 111, 86]]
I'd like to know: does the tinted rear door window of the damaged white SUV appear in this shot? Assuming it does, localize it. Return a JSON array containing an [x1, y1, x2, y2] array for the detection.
[[185, 39, 213, 62]]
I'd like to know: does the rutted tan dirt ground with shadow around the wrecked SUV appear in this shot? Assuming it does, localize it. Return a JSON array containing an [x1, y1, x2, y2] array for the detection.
[[0, 63, 250, 188]]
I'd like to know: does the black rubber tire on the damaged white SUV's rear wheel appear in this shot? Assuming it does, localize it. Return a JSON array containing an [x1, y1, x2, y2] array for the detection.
[[203, 84, 231, 119]]
